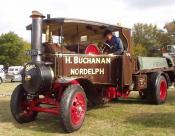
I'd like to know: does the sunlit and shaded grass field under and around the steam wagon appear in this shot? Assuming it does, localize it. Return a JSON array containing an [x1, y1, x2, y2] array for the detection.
[[0, 83, 175, 136]]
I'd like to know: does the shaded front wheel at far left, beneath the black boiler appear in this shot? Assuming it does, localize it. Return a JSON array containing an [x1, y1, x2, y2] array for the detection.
[[10, 84, 37, 123]]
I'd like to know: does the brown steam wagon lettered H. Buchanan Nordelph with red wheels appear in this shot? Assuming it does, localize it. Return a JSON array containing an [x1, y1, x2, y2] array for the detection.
[[10, 11, 175, 132]]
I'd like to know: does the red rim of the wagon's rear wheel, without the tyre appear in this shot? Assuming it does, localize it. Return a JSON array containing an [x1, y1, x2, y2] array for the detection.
[[160, 81, 167, 100]]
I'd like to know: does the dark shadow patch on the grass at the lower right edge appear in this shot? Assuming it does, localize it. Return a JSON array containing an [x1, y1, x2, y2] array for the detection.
[[126, 112, 175, 129]]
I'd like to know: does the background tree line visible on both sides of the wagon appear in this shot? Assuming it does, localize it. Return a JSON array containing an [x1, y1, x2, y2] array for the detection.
[[0, 23, 175, 66]]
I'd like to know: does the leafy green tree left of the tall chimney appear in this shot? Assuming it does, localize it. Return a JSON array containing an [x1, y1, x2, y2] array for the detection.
[[0, 32, 30, 65]]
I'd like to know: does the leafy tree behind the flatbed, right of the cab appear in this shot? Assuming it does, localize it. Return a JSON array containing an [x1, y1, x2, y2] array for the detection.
[[132, 23, 171, 56]]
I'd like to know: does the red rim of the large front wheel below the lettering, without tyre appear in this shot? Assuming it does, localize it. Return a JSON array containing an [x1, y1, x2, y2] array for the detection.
[[71, 93, 86, 125]]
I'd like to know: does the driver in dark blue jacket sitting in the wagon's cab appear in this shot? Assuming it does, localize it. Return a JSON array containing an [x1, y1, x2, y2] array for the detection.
[[103, 29, 124, 55]]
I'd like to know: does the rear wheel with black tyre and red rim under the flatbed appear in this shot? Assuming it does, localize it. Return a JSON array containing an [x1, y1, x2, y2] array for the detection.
[[149, 73, 168, 104]]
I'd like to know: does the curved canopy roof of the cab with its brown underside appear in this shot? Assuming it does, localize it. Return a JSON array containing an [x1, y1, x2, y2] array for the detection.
[[26, 18, 128, 40]]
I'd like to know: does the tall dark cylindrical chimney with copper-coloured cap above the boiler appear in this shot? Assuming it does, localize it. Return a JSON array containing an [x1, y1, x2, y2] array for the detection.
[[30, 11, 44, 62]]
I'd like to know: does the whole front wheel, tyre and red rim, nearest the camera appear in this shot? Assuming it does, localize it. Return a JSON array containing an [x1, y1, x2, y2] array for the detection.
[[60, 85, 87, 133]]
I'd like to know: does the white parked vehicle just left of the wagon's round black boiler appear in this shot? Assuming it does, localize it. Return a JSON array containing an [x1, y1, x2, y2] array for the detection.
[[6, 66, 23, 82]]
